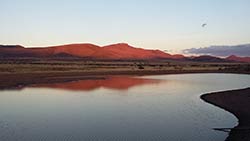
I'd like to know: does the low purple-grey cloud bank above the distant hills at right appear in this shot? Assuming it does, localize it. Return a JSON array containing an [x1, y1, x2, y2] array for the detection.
[[183, 44, 250, 57]]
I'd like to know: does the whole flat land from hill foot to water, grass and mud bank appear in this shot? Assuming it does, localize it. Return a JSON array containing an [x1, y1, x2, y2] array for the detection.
[[0, 59, 250, 89]]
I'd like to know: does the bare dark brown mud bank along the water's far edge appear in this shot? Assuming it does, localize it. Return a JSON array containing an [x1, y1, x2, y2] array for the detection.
[[0, 70, 249, 90]]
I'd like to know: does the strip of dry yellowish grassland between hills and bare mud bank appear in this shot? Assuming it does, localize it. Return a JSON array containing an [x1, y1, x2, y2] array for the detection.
[[0, 59, 250, 74]]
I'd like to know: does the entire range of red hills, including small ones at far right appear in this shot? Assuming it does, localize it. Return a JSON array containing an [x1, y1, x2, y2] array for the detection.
[[0, 43, 250, 62]]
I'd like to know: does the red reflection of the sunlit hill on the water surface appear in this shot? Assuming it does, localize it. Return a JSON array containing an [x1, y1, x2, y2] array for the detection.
[[34, 76, 162, 91]]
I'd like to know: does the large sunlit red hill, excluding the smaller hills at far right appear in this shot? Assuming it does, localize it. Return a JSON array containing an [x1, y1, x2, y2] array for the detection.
[[0, 43, 184, 60]]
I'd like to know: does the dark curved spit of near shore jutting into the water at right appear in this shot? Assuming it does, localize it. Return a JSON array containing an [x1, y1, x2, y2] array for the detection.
[[201, 88, 250, 141]]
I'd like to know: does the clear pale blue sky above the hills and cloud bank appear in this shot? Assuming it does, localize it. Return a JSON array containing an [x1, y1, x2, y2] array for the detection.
[[0, 0, 250, 52]]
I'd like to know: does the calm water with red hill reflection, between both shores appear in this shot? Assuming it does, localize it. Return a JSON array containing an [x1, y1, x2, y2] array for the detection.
[[0, 74, 250, 141]]
